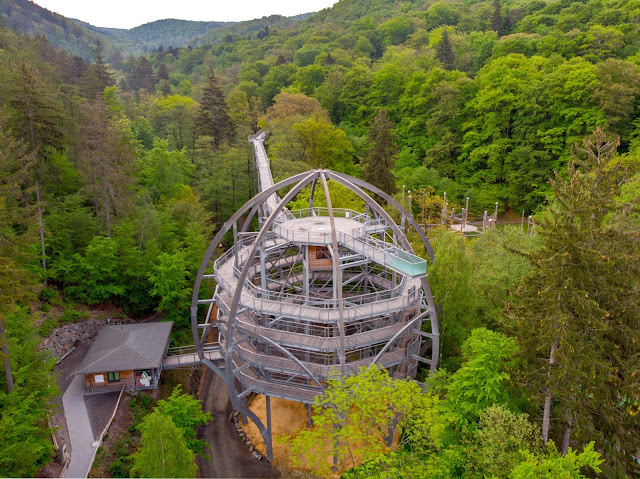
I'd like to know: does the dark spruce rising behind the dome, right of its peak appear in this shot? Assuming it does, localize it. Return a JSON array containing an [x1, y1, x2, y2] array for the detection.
[[362, 108, 398, 194]]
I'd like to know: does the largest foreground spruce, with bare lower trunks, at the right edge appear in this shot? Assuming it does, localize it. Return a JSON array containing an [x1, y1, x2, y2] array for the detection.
[[508, 129, 640, 475]]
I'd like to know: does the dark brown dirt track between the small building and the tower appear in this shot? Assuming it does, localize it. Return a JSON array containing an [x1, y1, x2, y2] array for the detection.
[[197, 368, 280, 478]]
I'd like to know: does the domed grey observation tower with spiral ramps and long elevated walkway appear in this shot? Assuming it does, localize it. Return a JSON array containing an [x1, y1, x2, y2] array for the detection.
[[191, 133, 439, 459]]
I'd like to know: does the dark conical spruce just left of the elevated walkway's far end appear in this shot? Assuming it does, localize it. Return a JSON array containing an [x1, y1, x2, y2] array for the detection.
[[196, 69, 231, 152]]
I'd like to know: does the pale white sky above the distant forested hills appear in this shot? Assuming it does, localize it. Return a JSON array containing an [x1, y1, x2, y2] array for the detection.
[[35, 0, 337, 28]]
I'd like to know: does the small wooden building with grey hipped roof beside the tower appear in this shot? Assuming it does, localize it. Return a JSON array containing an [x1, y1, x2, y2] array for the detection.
[[76, 322, 173, 393]]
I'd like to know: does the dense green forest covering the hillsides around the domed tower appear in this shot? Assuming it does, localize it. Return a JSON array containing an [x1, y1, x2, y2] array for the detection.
[[0, 0, 640, 478]]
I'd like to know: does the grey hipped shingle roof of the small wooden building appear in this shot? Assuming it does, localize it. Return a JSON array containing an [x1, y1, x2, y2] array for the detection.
[[76, 321, 173, 374]]
